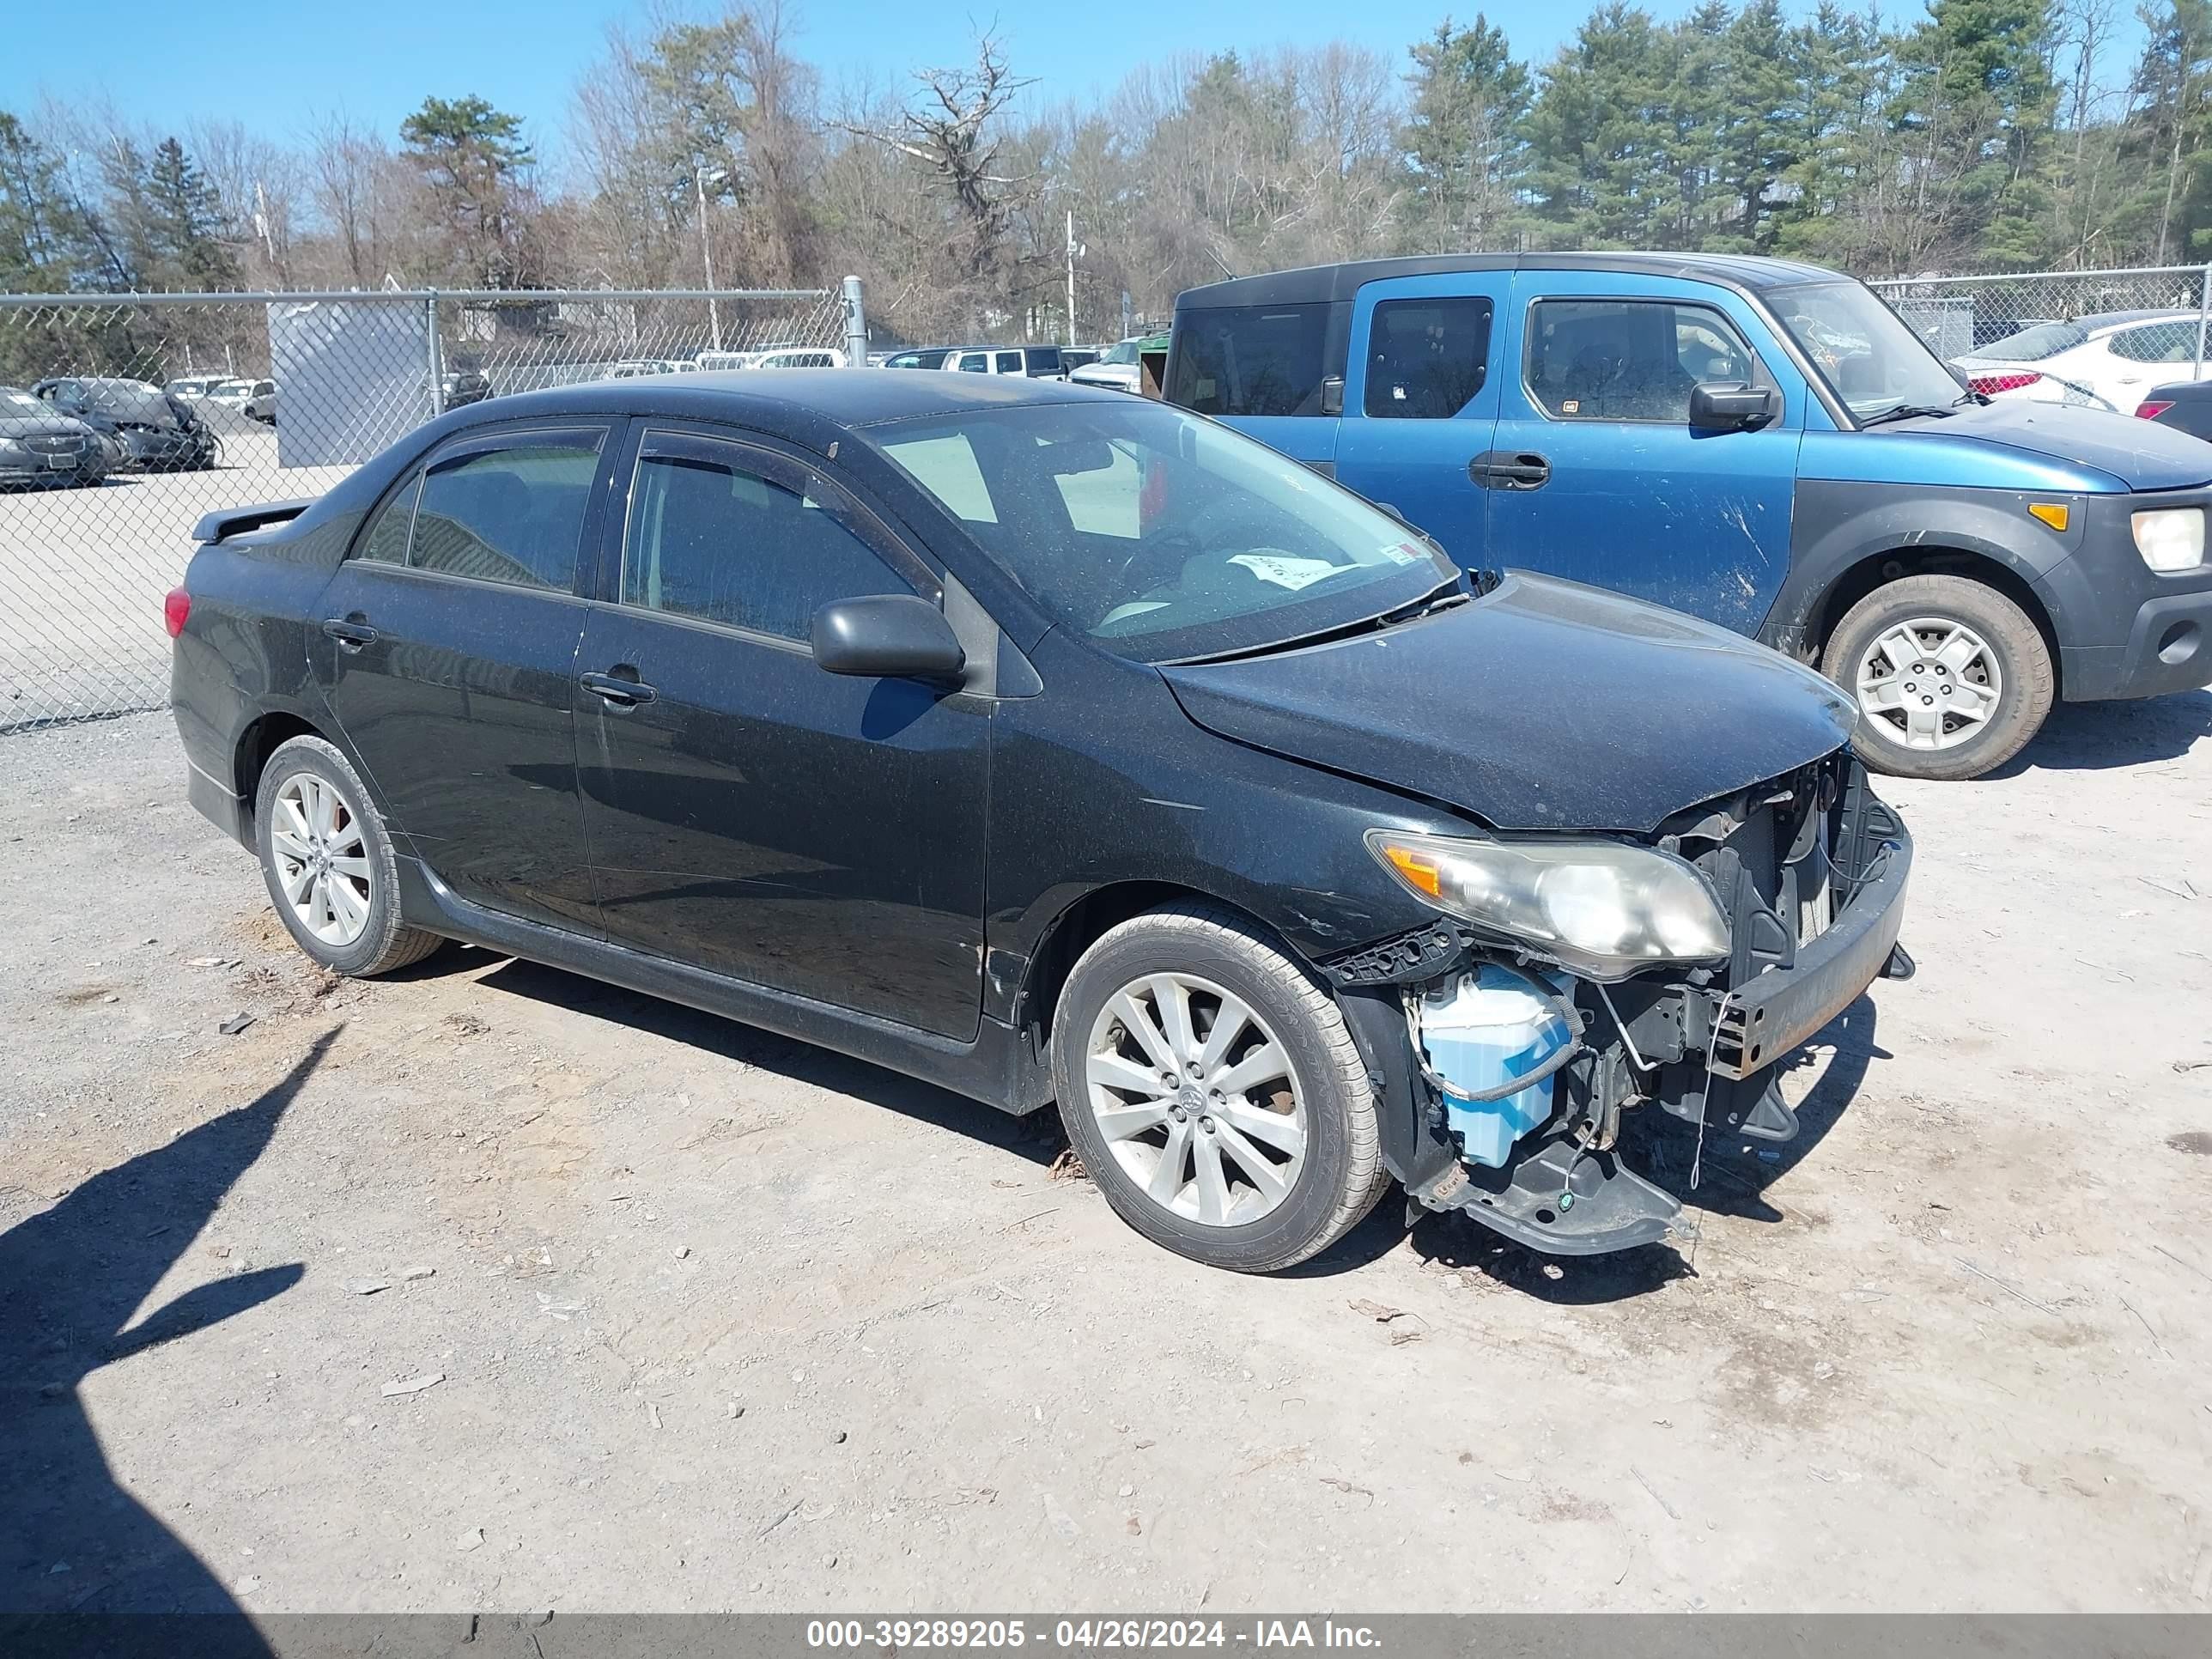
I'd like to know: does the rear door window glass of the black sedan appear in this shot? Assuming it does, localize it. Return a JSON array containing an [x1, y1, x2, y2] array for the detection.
[[409, 434, 599, 592]]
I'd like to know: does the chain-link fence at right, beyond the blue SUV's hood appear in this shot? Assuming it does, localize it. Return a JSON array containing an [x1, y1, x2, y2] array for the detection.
[[1869, 265, 2212, 400]]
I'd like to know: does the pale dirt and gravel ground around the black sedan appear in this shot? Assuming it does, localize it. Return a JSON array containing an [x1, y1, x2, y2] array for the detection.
[[0, 695, 2212, 1610]]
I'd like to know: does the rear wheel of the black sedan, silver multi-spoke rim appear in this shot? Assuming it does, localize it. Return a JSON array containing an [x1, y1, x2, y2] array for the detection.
[[254, 737, 445, 978]]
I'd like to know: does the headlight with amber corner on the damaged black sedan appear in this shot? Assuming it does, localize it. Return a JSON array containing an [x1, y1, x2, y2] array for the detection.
[[1367, 830, 1729, 980]]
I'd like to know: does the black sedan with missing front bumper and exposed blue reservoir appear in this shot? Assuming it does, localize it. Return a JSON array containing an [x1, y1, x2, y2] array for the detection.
[[168, 369, 1911, 1272]]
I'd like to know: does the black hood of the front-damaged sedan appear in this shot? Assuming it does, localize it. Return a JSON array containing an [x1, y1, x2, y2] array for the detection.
[[1161, 573, 1856, 834]]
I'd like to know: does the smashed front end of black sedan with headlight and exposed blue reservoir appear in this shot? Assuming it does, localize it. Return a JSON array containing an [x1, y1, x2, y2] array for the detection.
[[1321, 750, 1913, 1255]]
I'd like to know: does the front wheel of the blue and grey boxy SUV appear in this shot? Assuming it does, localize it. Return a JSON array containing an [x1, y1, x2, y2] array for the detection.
[[1820, 575, 2057, 781]]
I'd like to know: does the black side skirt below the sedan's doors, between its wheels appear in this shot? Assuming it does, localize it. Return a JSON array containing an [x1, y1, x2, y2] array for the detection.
[[398, 858, 1051, 1113]]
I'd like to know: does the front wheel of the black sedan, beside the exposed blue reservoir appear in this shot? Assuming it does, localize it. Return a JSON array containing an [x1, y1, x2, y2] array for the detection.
[[1053, 905, 1389, 1272]]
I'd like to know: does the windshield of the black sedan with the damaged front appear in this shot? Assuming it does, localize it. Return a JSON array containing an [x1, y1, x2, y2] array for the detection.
[[863, 403, 1458, 661]]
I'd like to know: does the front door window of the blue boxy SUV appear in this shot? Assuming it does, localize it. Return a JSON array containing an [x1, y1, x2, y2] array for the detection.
[[1526, 299, 1771, 425]]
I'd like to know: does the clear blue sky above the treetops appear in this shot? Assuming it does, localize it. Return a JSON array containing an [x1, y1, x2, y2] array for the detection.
[[13, 0, 1831, 171]]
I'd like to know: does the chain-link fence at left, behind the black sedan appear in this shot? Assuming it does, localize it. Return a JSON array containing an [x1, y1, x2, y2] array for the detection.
[[0, 281, 867, 732]]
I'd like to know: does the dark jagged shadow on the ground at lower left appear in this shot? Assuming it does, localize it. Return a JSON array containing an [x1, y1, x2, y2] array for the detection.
[[0, 1029, 338, 1655]]
